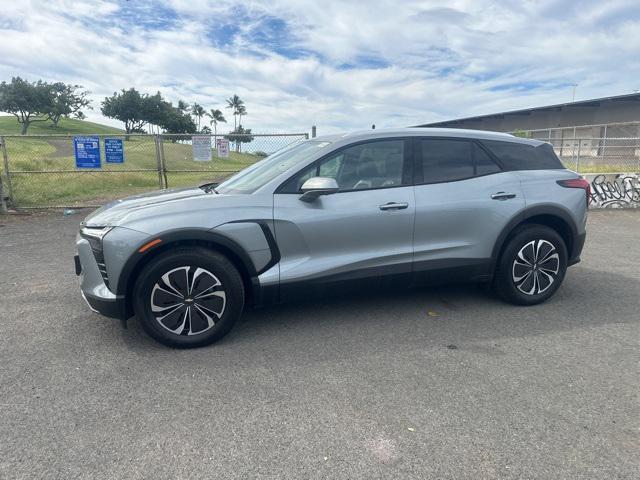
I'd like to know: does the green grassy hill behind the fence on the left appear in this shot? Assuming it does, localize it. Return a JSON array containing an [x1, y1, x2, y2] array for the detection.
[[0, 116, 262, 207]]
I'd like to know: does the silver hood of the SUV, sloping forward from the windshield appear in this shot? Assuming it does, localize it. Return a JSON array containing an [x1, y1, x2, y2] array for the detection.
[[82, 187, 210, 227]]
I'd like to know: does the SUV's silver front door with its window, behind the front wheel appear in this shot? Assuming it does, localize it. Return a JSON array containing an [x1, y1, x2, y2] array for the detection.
[[274, 139, 415, 298]]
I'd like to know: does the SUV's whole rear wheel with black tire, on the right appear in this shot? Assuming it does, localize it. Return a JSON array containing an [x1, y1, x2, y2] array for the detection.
[[493, 224, 567, 305]]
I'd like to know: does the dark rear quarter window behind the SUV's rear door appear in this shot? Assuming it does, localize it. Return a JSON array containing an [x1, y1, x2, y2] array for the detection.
[[482, 140, 564, 170]]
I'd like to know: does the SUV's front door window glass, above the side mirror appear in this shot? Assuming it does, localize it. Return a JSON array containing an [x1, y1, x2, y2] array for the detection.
[[280, 140, 409, 193]]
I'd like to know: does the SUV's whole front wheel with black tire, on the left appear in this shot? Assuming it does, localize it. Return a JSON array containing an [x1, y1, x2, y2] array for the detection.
[[133, 247, 244, 348]]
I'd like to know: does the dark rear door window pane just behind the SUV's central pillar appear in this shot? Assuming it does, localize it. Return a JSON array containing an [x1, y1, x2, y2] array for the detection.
[[420, 139, 474, 183]]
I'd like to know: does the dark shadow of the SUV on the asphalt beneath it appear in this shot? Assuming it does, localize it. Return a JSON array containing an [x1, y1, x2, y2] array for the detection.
[[121, 266, 640, 357]]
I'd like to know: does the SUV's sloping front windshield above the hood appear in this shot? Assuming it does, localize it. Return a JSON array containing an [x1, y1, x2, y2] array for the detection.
[[216, 140, 329, 193]]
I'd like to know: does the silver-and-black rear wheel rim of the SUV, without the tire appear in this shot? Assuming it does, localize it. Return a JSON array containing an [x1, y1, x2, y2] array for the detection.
[[511, 239, 560, 295]]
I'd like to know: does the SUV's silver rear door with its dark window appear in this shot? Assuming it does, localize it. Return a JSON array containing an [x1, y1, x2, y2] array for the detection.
[[414, 137, 525, 280]]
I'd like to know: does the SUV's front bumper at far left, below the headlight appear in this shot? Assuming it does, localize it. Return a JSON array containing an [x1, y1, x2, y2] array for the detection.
[[74, 236, 131, 320]]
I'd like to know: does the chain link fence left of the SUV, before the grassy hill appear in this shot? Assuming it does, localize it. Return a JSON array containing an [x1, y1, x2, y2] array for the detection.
[[0, 133, 308, 208]]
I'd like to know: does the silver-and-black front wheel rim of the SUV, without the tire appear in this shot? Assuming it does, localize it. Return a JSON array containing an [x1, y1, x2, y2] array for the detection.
[[150, 266, 227, 336]]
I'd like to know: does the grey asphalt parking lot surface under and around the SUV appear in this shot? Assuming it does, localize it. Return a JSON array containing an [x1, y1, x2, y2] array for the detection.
[[0, 211, 640, 479]]
